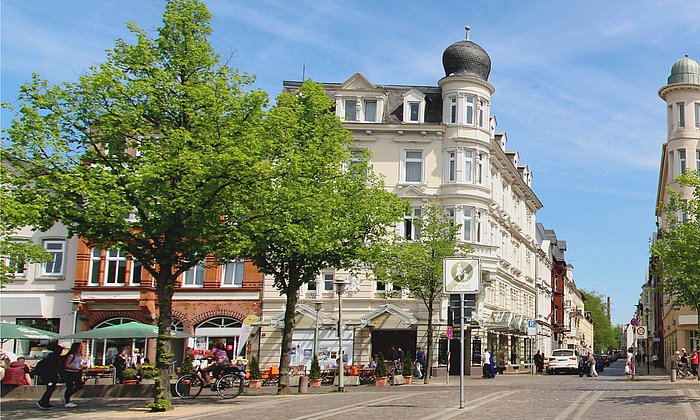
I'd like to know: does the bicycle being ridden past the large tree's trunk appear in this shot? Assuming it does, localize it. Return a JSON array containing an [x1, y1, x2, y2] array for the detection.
[[175, 366, 245, 400]]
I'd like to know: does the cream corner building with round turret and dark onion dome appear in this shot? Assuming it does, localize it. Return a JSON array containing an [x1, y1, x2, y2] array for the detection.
[[254, 31, 592, 377]]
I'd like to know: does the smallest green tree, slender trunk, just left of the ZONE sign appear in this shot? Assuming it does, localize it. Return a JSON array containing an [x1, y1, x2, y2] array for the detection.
[[372, 203, 471, 383]]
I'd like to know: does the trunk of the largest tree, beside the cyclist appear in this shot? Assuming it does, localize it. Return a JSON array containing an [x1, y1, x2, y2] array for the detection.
[[150, 267, 175, 411]]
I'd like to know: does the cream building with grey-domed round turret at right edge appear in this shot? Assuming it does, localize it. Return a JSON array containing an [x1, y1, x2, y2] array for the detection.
[[651, 56, 700, 368]]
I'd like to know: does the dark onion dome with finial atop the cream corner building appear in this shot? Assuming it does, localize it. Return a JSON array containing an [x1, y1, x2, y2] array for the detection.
[[442, 26, 491, 82]]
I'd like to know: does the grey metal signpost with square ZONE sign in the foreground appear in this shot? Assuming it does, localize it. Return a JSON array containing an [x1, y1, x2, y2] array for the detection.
[[443, 257, 481, 408]]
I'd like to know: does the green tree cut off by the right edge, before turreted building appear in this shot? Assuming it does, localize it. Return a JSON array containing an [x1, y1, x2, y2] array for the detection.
[[651, 172, 700, 340]]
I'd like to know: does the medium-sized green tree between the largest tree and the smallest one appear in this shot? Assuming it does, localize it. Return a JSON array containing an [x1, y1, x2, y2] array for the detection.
[[241, 81, 402, 394]]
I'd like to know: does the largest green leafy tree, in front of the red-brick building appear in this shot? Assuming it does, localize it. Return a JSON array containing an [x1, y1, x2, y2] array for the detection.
[[3, 0, 267, 411]]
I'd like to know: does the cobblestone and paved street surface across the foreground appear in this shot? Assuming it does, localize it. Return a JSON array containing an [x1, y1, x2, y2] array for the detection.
[[1, 362, 700, 420]]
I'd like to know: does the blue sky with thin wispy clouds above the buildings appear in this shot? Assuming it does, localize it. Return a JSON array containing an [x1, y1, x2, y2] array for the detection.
[[1, 0, 700, 323]]
